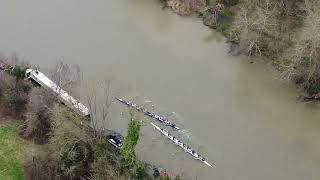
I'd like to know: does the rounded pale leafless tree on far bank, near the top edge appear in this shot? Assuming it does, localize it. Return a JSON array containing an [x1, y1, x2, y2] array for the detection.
[[233, 0, 279, 56]]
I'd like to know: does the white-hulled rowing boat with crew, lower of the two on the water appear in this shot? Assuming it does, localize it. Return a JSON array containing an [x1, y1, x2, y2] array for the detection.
[[151, 123, 213, 168]]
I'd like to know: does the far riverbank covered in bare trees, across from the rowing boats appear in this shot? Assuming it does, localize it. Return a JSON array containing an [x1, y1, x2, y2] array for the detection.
[[162, 0, 320, 99]]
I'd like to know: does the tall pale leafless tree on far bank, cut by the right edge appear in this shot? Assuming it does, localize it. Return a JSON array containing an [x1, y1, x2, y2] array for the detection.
[[283, 0, 320, 87]]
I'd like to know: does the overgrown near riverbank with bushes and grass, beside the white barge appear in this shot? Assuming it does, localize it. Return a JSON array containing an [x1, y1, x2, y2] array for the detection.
[[0, 60, 180, 180]]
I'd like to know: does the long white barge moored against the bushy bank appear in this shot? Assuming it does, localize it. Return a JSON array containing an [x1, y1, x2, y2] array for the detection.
[[25, 69, 90, 120]]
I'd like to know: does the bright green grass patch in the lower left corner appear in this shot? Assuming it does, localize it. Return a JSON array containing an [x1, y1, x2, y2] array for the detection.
[[0, 123, 23, 180]]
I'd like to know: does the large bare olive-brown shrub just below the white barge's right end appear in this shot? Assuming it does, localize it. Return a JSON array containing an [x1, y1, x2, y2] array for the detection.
[[48, 104, 93, 179]]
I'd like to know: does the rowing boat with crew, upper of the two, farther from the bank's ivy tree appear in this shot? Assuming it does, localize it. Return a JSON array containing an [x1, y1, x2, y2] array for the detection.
[[115, 97, 180, 130]]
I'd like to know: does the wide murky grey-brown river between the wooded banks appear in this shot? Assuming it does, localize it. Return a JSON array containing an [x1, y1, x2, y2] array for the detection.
[[0, 0, 320, 180]]
